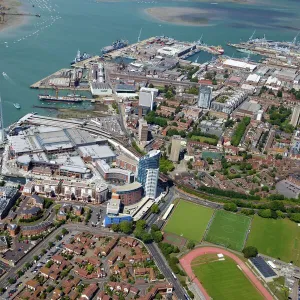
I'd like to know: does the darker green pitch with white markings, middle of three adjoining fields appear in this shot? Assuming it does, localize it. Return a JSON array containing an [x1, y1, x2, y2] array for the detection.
[[205, 210, 251, 251]]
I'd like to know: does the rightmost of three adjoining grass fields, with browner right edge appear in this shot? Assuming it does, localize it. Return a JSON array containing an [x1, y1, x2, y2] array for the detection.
[[247, 216, 300, 266]]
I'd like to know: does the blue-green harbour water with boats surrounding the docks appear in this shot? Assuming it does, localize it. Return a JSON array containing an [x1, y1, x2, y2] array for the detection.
[[0, 0, 300, 125]]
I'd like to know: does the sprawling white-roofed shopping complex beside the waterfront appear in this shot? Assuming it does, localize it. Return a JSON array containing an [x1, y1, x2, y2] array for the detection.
[[9, 126, 116, 179]]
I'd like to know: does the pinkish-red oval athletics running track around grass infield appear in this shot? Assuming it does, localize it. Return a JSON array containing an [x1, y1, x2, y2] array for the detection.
[[180, 247, 273, 300]]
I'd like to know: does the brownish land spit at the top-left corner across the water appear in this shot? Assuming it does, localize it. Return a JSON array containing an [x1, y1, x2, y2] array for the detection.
[[0, 0, 26, 33]]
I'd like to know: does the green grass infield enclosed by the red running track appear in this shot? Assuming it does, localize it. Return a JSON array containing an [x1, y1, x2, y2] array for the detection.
[[192, 255, 263, 300]]
